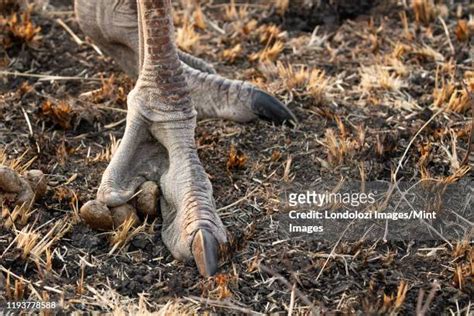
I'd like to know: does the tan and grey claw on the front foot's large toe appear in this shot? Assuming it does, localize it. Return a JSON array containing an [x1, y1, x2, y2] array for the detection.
[[192, 229, 219, 277]]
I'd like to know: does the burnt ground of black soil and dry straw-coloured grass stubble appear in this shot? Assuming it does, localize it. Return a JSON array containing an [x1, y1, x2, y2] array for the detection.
[[0, 0, 474, 315]]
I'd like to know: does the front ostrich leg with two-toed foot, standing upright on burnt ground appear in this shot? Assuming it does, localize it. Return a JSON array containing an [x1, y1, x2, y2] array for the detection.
[[97, 0, 226, 276]]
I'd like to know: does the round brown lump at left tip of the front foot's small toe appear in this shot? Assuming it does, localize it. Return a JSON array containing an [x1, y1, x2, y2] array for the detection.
[[79, 200, 114, 230]]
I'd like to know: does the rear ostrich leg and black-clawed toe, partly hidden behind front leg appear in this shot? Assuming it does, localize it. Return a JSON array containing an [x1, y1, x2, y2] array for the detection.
[[75, 0, 297, 124]]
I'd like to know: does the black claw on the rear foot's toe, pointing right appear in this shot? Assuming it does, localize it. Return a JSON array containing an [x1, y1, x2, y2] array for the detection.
[[252, 89, 298, 126]]
